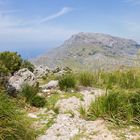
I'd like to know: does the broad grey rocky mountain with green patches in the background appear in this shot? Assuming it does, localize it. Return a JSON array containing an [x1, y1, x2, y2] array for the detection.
[[33, 33, 140, 70]]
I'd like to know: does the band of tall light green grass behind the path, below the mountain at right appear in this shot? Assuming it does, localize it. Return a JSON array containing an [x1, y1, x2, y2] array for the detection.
[[78, 68, 140, 89]]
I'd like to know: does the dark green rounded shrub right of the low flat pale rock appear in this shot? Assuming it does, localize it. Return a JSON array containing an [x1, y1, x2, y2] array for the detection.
[[59, 74, 76, 91]]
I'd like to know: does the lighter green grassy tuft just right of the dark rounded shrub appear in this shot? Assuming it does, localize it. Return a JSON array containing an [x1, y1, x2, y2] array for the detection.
[[79, 72, 94, 86]]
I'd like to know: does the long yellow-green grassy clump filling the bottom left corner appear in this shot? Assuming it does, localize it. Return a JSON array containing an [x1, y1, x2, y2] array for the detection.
[[0, 93, 35, 140]]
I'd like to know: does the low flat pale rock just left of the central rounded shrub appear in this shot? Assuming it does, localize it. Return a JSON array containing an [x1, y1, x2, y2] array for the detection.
[[40, 80, 59, 91]]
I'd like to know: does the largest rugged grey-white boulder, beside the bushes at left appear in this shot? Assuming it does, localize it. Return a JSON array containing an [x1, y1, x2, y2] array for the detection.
[[7, 68, 37, 92]]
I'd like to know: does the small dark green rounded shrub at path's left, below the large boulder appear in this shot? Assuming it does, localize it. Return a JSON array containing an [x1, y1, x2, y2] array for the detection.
[[30, 96, 46, 107]]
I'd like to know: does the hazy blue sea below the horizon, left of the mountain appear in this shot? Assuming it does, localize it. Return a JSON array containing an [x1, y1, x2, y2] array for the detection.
[[0, 42, 61, 59]]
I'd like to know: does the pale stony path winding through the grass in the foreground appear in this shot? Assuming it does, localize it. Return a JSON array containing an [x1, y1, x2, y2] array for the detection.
[[27, 87, 140, 140]]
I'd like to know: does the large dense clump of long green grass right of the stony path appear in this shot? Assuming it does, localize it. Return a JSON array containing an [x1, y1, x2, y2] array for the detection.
[[83, 90, 140, 125]]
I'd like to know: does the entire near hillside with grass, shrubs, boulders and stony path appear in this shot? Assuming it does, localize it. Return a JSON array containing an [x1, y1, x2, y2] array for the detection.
[[0, 52, 140, 140]]
